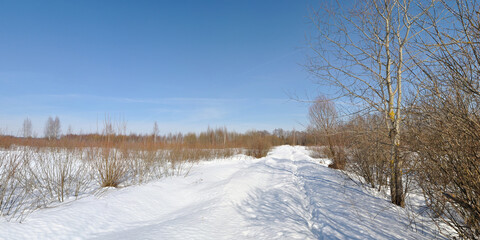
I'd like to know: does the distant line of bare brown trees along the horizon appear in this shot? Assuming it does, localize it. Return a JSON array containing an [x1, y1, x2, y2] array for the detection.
[[0, 116, 320, 155]]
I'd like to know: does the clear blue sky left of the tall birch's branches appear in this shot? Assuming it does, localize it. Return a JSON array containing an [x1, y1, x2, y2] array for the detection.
[[0, 0, 317, 136]]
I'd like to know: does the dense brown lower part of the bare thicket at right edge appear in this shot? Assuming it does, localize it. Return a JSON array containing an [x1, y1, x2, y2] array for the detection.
[[412, 95, 480, 239]]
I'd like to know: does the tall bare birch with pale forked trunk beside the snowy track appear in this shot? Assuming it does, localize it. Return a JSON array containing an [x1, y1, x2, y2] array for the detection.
[[308, 0, 436, 206]]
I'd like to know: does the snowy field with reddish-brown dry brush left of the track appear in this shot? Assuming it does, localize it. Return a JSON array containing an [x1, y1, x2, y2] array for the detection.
[[0, 128, 306, 220]]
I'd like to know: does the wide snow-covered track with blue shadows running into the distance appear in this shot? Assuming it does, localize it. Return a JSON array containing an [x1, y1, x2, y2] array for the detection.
[[0, 146, 441, 239]]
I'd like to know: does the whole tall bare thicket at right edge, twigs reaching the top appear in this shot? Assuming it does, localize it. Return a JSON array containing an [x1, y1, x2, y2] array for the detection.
[[409, 0, 480, 236]]
